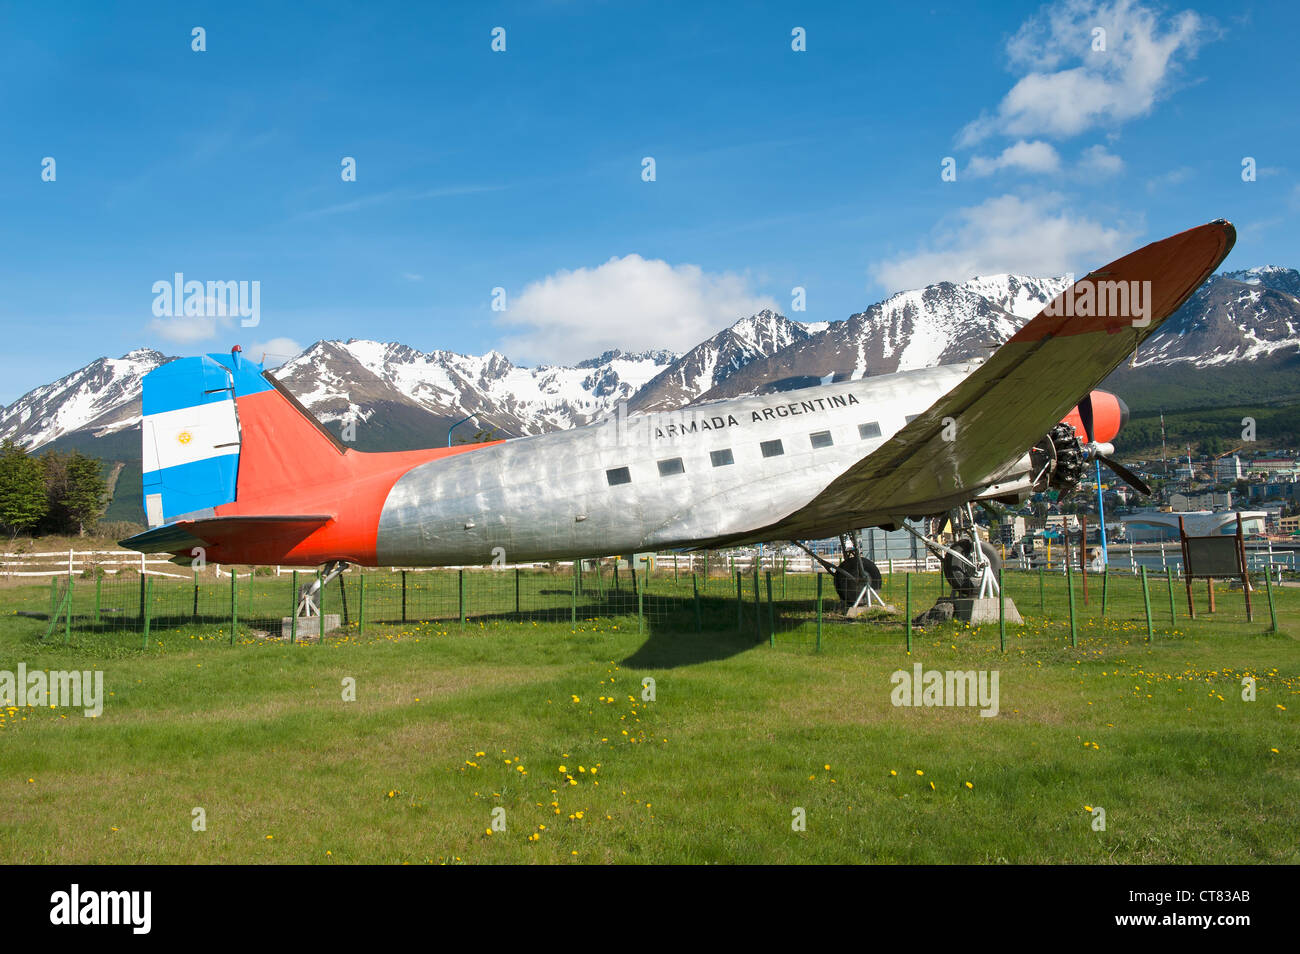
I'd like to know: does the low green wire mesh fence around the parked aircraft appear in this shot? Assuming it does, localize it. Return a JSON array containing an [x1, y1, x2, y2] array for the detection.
[[23, 554, 1281, 655]]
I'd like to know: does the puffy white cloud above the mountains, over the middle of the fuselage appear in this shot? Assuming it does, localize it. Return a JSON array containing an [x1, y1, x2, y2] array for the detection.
[[501, 255, 777, 363]]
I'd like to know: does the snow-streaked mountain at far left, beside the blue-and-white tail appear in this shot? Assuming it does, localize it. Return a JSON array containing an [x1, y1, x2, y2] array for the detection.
[[0, 348, 172, 447]]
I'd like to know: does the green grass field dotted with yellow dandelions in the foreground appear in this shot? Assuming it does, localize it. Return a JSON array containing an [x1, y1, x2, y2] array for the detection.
[[0, 576, 1300, 863]]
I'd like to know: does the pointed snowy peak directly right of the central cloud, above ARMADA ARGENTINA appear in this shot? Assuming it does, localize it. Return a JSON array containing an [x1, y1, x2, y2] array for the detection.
[[628, 309, 828, 411]]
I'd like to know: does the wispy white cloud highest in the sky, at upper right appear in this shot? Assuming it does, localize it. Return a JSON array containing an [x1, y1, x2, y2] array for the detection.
[[958, 0, 1212, 146]]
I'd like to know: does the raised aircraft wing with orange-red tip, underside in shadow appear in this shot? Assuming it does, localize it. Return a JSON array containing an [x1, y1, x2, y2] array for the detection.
[[745, 220, 1236, 539]]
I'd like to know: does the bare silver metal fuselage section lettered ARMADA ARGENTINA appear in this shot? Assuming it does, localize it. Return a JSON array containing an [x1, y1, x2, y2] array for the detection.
[[377, 363, 1019, 565]]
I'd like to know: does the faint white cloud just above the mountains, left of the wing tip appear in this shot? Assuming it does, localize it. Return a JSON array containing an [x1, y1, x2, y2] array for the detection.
[[868, 192, 1138, 291]]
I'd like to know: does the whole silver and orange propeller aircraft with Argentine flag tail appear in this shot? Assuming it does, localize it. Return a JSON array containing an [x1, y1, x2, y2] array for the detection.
[[122, 220, 1236, 611]]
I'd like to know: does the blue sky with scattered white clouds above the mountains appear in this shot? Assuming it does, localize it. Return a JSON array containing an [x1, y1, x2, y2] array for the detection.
[[0, 0, 1300, 403]]
